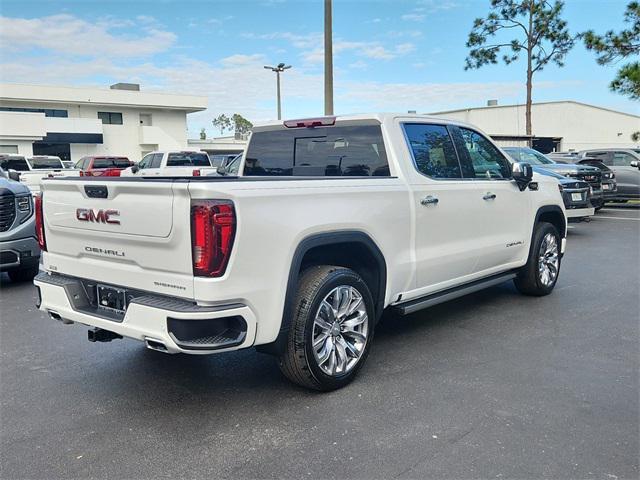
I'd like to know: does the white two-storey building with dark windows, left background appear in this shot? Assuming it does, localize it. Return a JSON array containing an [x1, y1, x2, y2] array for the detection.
[[0, 83, 207, 161]]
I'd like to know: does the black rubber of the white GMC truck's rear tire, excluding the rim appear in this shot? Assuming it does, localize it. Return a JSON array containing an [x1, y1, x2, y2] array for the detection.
[[278, 265, 375, 391]]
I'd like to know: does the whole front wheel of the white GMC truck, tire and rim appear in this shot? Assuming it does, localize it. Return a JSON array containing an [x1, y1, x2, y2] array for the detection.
[[513, 222, 561, 297]]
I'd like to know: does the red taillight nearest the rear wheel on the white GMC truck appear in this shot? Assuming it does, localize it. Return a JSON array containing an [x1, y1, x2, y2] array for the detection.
[[191, 200, 236, 277]]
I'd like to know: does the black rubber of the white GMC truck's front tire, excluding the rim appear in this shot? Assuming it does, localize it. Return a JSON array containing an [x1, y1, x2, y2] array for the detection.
[[513, 222, 562, 297]]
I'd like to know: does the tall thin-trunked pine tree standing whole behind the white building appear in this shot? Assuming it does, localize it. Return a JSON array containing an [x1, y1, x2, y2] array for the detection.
[[465, 0, 575, 135]]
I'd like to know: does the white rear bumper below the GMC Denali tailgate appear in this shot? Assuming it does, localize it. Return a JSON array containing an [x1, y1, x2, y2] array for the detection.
[[34, 273, 256, 355]]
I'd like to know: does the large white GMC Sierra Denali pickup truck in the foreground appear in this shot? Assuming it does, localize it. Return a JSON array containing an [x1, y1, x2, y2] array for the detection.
[[35, 114, 567, 390]]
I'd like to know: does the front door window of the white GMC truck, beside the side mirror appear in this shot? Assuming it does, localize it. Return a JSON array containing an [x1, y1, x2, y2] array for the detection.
[[460, 127, 511, 179]]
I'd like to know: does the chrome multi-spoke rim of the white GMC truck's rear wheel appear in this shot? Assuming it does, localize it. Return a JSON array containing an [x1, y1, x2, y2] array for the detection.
[[311, 285, 369, 377]]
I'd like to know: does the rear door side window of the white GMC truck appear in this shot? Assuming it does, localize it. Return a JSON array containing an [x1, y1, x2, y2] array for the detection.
[[404, 123, 462, 178]]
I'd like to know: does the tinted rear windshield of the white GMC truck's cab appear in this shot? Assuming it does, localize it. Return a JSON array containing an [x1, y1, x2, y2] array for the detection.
[[244, 125, 389, 177]]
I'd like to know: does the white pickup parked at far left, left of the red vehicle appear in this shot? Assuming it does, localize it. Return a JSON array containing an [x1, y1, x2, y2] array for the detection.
[[0, 154, 80, 195]]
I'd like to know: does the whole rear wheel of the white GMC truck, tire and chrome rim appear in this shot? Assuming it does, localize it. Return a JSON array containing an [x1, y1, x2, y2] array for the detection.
[[278, 265, 375, 391]]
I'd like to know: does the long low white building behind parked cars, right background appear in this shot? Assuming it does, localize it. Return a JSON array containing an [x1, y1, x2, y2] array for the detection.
[[432, 100, 640, 153]]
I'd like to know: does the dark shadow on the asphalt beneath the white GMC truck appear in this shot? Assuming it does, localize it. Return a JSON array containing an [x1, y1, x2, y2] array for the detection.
[[78, 284, 522, 404]]
